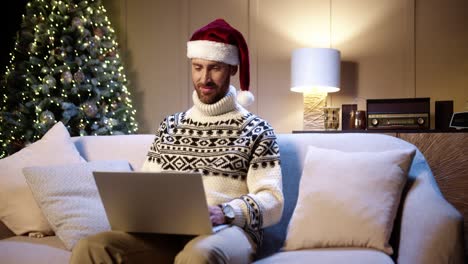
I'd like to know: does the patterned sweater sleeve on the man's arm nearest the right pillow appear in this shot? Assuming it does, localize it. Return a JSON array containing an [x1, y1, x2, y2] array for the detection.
[[229, 128, 284, 234]]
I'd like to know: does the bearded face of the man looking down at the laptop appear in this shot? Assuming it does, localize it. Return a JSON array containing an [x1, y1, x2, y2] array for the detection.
[[192, 59, 237, 104]]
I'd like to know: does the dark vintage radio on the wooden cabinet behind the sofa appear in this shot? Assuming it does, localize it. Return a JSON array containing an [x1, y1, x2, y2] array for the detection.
[[367, 98, 431, 130]]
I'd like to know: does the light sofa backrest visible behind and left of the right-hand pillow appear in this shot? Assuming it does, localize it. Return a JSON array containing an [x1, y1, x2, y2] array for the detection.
[[258, 133, 414, 258]]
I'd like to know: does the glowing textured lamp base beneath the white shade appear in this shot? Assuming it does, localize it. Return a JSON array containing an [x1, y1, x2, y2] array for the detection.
[[304, 92, 327, 130]]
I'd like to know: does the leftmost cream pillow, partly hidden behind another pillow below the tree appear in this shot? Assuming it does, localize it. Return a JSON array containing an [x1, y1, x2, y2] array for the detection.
[[0, 122, 84, 235]]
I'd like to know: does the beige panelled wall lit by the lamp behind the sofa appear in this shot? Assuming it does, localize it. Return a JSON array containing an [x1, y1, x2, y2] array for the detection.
[[104, 0, 468, 133]]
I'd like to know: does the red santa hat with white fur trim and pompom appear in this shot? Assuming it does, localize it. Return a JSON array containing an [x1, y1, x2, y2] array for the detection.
[[187, 19, 254, 106]]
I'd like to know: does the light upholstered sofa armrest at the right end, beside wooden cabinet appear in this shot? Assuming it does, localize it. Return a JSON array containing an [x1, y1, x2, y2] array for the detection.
[[397, 151, 464, 264]]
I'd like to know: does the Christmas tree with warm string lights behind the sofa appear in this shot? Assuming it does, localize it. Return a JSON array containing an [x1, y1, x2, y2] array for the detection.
[[0, 0, 137, 158]]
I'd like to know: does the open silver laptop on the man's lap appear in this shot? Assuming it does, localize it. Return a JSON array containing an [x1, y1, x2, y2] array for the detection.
[[93, 171, 226, 235]]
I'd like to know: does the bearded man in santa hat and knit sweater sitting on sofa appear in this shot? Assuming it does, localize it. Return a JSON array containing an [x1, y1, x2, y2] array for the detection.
[[71, 19, 283, 263]]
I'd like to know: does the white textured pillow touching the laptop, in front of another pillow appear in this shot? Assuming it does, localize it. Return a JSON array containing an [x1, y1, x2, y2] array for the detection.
[[23, 161, 131, 250]]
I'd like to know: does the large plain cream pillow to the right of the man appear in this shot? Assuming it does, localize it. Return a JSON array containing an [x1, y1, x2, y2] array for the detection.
[[284, 146, 415, 254]]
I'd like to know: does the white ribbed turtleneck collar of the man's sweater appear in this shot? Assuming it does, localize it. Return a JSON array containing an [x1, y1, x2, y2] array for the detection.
[[187, 85, 248, 121]]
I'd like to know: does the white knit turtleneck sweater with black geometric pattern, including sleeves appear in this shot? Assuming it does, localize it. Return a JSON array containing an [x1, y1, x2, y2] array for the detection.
[[142, 86, 284, 244]]
